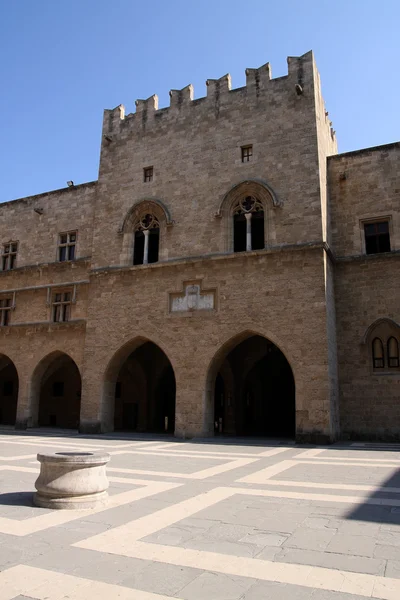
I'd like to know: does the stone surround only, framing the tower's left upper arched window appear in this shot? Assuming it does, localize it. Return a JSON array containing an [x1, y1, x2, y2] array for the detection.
[[118, 198, 173, 266]]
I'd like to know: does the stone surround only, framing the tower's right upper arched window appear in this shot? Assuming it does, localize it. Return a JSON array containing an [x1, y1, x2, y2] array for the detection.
[[215, 179, 282, 252]]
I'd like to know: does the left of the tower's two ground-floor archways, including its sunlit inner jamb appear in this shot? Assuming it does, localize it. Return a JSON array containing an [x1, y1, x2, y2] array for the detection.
[[100, 336, 176, 433]]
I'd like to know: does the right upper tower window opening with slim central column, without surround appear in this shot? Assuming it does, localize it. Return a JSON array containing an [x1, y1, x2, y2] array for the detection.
[[232, 196, 265, 252]]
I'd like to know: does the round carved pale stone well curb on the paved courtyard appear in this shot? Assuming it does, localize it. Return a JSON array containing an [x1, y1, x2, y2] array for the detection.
[[33, 452, 110, 509]]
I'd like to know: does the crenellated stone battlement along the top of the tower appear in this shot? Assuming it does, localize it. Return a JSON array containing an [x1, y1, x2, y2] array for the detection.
[[103, 51, 332, 144]]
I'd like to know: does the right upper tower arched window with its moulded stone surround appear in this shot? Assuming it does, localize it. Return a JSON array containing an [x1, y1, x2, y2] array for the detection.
[[215, 179, 282, 252]]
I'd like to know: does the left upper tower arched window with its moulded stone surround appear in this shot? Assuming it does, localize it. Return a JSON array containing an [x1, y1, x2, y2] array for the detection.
[[119, 198, 173, 265]]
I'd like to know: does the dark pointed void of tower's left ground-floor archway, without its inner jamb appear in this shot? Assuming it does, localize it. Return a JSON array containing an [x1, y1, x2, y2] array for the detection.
[[114, 341, 176, 433]]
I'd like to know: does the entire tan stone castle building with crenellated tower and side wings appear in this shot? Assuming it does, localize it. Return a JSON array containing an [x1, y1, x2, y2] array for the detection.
[[0, 52, 400, 442]]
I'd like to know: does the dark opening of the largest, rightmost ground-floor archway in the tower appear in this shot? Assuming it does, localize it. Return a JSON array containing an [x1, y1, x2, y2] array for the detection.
[[214, 335, 295, 438]]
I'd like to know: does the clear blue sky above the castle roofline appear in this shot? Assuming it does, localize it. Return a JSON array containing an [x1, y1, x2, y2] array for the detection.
[[0, 0, 400, 202]]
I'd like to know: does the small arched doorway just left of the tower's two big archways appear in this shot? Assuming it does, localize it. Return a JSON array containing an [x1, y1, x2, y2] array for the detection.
[[33, 352, 81, 429]]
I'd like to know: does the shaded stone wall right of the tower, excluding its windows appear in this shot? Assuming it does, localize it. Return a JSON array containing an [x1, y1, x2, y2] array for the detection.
[[328, 143, 400, 440]]
